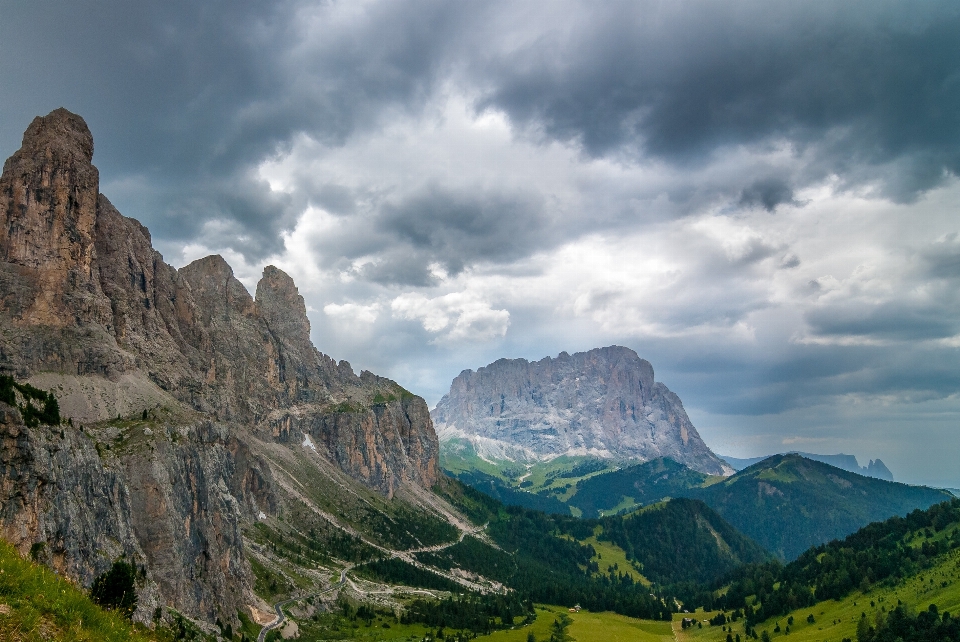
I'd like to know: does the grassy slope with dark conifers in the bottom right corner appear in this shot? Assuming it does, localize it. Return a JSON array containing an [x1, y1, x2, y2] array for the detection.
[[470, 501, 960, 642]]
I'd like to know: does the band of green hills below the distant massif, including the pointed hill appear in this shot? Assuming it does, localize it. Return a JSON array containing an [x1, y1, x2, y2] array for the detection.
[[448, 454, 952, 560]]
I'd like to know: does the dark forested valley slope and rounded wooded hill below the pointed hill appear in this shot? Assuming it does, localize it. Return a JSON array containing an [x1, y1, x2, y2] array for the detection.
[[432, 480, 768, 600]]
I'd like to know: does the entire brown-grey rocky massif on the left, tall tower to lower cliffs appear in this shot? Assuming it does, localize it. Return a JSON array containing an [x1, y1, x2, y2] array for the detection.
[[0, 109, 439, 622]]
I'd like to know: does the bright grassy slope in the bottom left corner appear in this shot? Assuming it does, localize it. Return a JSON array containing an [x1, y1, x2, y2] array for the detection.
[[0, 540, 163, 642]]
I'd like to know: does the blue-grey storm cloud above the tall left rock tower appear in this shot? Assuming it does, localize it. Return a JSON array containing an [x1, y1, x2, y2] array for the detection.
[[0, 1, 470, 259]]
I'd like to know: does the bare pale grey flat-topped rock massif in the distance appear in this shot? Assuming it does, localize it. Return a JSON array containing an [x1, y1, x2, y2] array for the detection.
[[432, 346, 725, 474]]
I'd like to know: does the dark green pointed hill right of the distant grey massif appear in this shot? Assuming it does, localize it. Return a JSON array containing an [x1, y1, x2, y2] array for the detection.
[[689, 455, 951, 560]]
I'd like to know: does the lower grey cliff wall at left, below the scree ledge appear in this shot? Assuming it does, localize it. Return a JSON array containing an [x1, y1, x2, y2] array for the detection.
[[0, 403, 275, 621]]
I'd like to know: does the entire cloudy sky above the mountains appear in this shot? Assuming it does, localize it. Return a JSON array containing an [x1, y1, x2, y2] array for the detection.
[[0, 0, 960, 488]]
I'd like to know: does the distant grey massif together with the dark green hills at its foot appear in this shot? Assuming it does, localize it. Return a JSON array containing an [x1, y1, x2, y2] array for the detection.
[[431, 346, 950, 560]]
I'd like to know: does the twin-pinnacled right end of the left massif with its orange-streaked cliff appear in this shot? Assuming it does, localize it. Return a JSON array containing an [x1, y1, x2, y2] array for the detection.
[[173, 251, 439, 495]]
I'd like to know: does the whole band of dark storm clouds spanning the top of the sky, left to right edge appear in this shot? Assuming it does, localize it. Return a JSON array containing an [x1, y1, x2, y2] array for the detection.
[[0, 1, 960, 262]]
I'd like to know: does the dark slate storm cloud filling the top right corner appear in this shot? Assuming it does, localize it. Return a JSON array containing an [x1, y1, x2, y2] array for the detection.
[[486, 2, 960, 200]]
